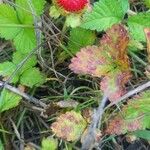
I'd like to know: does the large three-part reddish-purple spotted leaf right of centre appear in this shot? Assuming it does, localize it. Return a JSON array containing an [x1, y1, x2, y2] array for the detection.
[[69, 25, 131, 101]]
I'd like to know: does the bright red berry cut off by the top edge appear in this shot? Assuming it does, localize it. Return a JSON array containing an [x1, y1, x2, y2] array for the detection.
[[56, 0, 88, 13]]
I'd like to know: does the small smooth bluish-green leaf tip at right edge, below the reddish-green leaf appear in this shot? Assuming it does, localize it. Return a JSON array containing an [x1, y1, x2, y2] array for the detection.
[[133, 130, 150, 140]]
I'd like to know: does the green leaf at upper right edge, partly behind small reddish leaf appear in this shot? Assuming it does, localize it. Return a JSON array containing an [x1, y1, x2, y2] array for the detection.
[[128, 13, 150, 41]]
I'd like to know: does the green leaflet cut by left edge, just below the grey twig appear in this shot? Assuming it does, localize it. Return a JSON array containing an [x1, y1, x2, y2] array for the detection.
[[0, 89, 22, 112]]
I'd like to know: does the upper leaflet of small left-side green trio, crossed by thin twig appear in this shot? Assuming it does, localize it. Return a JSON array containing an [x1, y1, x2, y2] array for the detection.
[[13, 51, 37, 71]]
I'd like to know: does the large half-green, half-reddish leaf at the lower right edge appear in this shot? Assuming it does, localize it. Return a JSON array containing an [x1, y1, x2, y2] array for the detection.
[[107, 91, 150, 135]]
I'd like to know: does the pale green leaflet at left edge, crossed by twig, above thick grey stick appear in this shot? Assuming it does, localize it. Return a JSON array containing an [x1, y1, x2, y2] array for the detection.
[[0, 61, 19, 83]]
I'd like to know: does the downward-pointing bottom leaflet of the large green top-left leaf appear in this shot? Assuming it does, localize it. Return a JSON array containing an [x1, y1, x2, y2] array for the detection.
[[14, 28, 36, 54]]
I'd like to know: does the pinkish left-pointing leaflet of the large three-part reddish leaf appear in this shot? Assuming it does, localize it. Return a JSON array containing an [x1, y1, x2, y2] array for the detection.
[[69, 46, 112, 77]]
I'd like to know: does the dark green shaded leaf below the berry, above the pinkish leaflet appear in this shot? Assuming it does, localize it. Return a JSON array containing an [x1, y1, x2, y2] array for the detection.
[[68, 27, 96, 54]]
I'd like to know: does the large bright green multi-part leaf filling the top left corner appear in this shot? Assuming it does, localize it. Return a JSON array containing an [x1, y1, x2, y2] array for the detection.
[[0, 0, 45, 53]]
